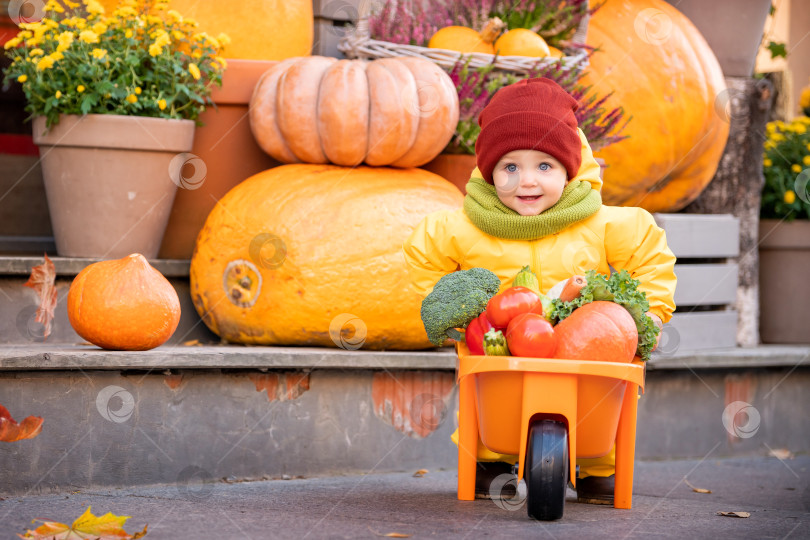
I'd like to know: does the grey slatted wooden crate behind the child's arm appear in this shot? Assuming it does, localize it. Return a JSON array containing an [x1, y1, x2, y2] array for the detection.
[[654, 214, 740, 354]]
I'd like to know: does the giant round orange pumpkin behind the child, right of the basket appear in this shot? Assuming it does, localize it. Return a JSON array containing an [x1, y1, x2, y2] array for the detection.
[[583, 0, 729, 212]]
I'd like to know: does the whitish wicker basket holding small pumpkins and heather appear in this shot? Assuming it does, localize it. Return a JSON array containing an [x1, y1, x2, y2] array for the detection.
[[338, 16, 589, 75]]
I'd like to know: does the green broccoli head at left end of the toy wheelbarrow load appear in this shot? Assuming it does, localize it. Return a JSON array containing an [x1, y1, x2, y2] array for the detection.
[[421, 268, 501, 347]]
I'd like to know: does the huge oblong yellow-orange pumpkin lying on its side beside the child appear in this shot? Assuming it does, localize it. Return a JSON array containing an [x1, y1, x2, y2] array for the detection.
[[191, 164, 463, 349]]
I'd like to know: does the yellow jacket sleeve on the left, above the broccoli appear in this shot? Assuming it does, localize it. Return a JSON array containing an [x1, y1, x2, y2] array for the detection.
[[402, 210, 460, 298]]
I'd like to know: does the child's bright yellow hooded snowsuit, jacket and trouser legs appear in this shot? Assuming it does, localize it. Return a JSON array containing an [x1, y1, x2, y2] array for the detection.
[[403, 130, 676, 477]]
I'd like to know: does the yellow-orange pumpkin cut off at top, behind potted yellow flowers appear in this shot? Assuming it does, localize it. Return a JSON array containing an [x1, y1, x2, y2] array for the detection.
[[101, 0, 314, 60]]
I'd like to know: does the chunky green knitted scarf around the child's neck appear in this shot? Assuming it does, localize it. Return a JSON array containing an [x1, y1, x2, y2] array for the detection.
[[464, 177, 602, 240]]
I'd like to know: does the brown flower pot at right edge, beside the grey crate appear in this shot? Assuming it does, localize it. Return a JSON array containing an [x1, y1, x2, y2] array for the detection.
[[759, 220, 810, 343]]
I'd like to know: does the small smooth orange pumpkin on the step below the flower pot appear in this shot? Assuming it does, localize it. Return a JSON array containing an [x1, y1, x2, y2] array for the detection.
[[67, 253, 180, 351]]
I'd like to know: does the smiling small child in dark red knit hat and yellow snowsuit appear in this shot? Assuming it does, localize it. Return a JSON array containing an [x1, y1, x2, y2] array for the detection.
[[403, 78, 676, 504]]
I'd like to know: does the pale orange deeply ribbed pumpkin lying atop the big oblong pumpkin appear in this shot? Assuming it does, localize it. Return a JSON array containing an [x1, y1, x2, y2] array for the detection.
[[250, 56, 459, 167]]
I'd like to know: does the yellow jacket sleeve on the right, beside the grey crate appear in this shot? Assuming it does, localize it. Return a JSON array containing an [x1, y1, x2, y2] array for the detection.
[[605, 207, 677, 322]]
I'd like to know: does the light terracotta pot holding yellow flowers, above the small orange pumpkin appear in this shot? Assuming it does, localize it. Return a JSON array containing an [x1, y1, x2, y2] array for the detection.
[[33, 114, 194, 259]]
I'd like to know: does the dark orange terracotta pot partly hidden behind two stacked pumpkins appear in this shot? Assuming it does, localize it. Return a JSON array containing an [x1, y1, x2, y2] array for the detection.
[[160, 60, 279, 259]]
